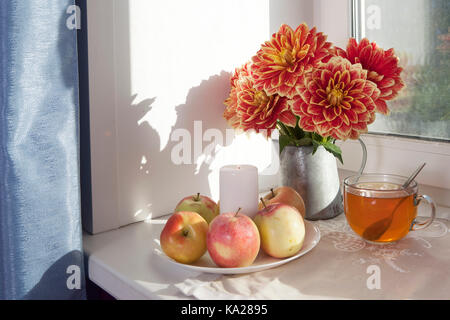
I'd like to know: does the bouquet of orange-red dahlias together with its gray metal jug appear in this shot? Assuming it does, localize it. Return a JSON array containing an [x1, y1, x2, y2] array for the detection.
[[224, 23, 404, 220]]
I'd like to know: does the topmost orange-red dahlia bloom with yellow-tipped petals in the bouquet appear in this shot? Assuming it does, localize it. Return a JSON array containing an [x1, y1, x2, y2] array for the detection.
[[252, 23, 331, 98]]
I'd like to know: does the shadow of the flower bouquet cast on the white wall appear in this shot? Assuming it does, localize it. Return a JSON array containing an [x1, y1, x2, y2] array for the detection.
[[117, 71, 231, 221]]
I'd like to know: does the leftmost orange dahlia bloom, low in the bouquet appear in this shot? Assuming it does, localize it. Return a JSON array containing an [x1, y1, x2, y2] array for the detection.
[[224, 63, 296, 136]]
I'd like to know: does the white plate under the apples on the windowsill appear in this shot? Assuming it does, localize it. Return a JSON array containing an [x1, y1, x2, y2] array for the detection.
[[154, 221, 320, 274]]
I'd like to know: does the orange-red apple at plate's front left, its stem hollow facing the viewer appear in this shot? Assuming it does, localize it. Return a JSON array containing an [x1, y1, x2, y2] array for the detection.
[[160, 211, 208, 264]]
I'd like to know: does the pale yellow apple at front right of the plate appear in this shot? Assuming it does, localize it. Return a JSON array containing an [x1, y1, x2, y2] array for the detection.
[[253, 202, 305, 258]]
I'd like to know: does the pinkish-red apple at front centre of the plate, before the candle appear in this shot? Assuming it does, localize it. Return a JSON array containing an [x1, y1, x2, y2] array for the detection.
[[206, 212, 260, 268]]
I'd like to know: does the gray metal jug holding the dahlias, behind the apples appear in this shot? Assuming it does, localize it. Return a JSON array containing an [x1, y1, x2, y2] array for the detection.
[[280, 146, 344, 220]]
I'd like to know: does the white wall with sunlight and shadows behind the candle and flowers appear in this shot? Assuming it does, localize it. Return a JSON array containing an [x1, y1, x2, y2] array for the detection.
[[84, 0, 348, 233]]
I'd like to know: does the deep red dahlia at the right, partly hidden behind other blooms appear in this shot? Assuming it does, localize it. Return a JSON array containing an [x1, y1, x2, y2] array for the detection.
[[334, 38, 405, 114]]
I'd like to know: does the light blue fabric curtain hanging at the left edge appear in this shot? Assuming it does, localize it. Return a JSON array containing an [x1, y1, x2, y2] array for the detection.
[[0, 0, 85, 299]]
